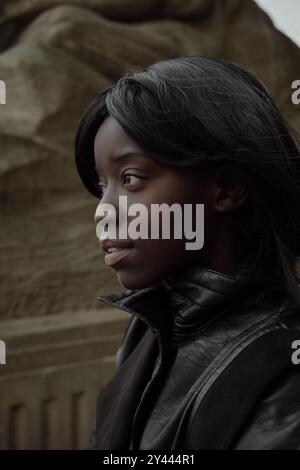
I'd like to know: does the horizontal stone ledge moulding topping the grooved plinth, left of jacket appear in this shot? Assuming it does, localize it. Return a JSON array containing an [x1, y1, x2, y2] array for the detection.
[[0, 309, 130, 377]]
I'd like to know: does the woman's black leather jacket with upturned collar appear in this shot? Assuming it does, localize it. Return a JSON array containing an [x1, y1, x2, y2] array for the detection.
[[87, 267, 300, 450]]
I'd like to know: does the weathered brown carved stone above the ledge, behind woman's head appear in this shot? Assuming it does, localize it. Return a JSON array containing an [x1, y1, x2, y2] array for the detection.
[[0, 0, 300, 319]]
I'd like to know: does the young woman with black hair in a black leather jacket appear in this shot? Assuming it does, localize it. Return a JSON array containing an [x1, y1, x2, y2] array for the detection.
[[76, 56, 300, 450]]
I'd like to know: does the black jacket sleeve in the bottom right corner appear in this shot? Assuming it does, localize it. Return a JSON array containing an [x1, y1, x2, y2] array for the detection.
[[234, 366, 300, 450]]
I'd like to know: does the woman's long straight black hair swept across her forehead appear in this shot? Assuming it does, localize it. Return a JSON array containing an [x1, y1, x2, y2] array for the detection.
[[75, 56, 300, 306]]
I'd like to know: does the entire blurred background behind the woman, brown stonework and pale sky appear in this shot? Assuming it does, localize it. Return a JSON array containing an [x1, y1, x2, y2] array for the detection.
[[0, 0, 300, 449]]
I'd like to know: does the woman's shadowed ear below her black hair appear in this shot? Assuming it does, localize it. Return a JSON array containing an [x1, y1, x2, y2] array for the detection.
[[214, 163, 248, 213]]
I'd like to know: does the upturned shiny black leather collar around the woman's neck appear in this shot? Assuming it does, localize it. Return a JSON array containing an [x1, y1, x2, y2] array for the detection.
[[97, 264, 268, 343]]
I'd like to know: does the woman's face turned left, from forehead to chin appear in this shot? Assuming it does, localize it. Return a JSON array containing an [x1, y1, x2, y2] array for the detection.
[[94, 116, 226, 289]]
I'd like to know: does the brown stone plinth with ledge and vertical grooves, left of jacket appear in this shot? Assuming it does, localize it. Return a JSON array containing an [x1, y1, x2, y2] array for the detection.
[[0, 309, 129, 450]]
